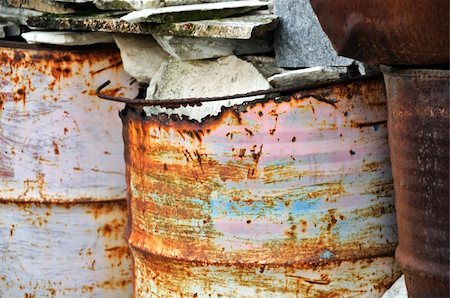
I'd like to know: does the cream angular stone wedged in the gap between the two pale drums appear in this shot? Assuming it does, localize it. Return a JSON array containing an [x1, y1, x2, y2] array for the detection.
[[113, 34, 169, 84]]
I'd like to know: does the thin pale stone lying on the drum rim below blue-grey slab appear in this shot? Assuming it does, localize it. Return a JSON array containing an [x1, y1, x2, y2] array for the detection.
[[268, 66, 347, 88]]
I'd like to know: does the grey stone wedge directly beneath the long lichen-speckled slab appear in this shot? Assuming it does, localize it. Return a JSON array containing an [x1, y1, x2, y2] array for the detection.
[[153, 34, 273, 60]]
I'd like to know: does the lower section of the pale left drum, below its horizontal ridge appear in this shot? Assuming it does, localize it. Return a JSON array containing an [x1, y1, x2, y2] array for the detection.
[[0, 201, 132, 298]]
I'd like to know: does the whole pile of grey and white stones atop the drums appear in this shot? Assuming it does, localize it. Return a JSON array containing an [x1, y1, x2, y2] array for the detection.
[[0, 0, 372, 121]]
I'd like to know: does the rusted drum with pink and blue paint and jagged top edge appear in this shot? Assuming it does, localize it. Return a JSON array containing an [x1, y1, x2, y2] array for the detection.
[[121, 79, 399, 297]]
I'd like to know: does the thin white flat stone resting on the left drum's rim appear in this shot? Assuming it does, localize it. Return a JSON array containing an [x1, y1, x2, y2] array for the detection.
[[22, 31, 114, 46]]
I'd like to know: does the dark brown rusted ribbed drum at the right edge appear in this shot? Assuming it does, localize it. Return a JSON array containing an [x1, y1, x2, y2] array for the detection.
[[384, 68, 450, 297]]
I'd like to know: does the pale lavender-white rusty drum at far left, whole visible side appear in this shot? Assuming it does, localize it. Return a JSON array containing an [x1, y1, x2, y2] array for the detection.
[[0, 42, 137, 297]]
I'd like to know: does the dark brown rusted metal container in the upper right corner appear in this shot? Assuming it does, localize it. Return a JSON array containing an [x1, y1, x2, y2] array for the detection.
[[310, 0, 450, 65]]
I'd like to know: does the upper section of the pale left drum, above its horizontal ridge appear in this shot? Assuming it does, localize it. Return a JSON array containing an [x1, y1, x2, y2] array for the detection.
[[0, 43, 137, 202]]
